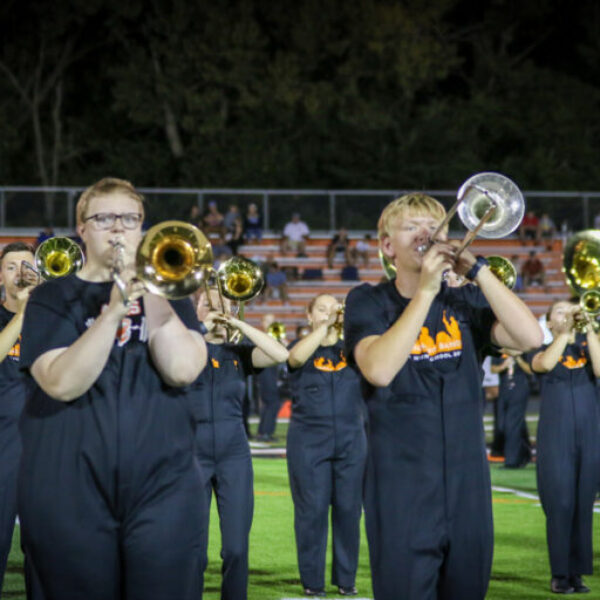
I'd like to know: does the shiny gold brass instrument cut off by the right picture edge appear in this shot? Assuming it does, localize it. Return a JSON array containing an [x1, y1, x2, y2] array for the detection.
[[563, 229, 600, 331]]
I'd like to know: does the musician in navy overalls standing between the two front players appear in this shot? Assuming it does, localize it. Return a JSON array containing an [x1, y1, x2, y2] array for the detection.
[[287, 294, 367, 597]]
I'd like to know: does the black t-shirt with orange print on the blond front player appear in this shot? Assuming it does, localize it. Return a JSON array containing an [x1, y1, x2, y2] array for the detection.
[[344, 281, 496, 400]]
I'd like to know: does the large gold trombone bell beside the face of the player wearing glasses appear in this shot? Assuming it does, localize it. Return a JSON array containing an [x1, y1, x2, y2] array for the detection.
[[136, 221, 213, 300]]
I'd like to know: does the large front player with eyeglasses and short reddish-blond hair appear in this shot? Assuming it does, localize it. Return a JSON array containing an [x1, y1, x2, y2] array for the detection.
[[18, 178, 206, 600]]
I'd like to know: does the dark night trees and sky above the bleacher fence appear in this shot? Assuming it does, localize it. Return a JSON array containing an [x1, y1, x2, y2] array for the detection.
[[0, 0, 600, 220]]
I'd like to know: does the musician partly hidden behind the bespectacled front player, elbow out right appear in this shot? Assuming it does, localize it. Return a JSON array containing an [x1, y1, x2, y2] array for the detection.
[[192, 289, 288, 600]]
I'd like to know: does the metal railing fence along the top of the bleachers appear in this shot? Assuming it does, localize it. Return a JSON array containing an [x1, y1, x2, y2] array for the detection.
[[0, 186, 600, 232]]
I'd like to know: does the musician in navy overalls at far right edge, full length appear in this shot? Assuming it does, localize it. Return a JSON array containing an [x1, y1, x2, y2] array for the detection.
[[529, 301, 600, 594]]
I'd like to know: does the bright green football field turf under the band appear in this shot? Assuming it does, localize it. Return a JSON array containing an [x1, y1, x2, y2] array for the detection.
[[3, 458, 600, 600]]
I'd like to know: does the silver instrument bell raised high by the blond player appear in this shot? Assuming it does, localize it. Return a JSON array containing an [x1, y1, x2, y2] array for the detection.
[[457, 172, 525, 238]]
